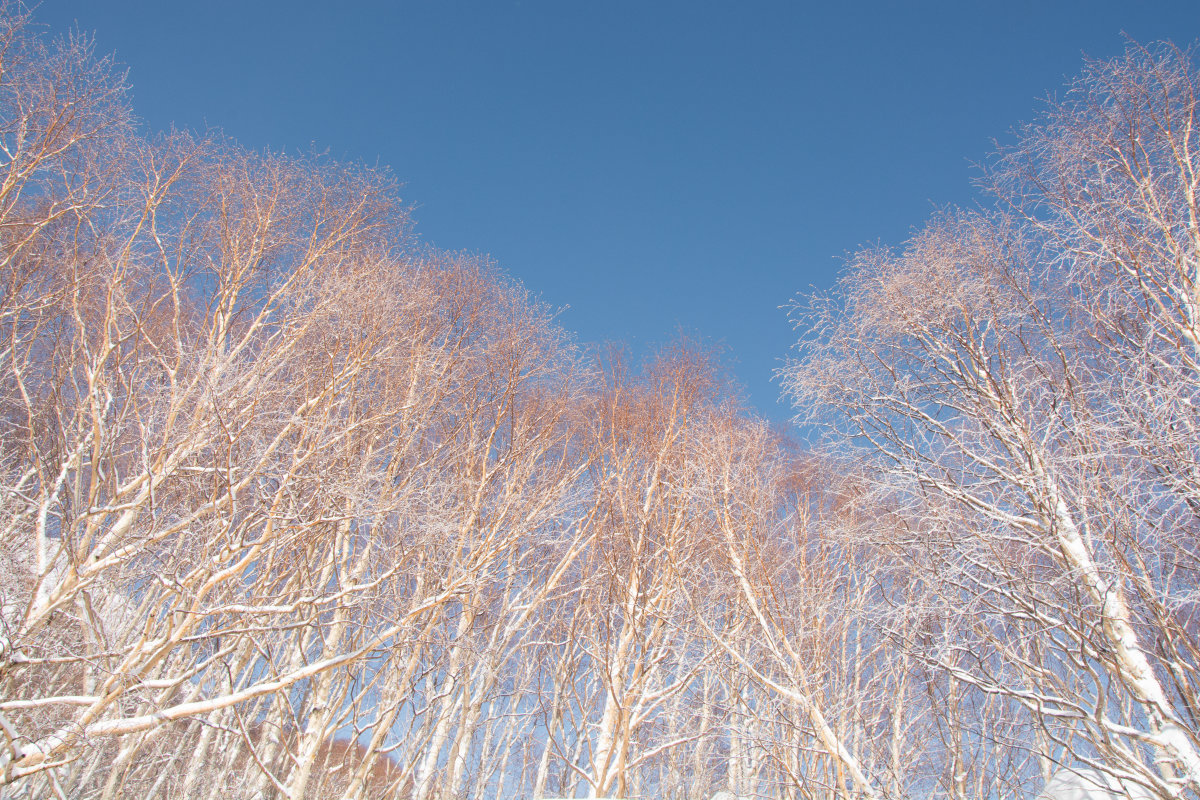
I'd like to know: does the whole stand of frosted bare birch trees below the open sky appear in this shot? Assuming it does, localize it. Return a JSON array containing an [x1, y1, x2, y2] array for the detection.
[[0, 5, 1200, 800]]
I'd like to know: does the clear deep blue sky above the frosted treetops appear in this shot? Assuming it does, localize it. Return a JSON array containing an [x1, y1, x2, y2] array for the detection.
[[36, 0, 1200, 419]]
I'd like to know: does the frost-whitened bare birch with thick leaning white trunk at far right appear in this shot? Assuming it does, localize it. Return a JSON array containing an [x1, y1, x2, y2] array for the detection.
[[786, 47, 1200, 796]]
